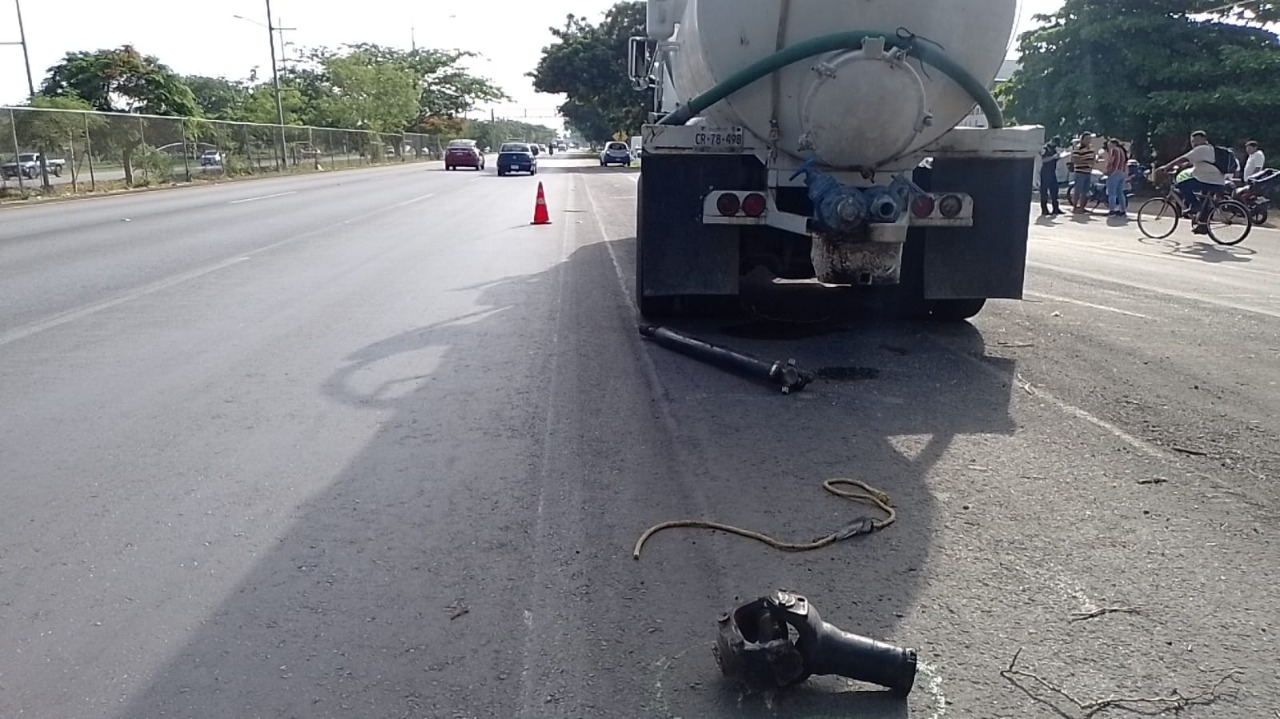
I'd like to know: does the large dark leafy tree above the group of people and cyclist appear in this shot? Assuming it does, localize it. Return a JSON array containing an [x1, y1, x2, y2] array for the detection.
[[997, 0, 1280, 160]]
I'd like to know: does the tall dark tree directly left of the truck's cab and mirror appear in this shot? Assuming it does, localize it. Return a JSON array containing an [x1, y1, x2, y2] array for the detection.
[[529, 0, 653, 142]]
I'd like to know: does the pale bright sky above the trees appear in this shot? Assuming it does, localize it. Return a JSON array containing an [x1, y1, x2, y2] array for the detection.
[[0, 0, 1061, 125]]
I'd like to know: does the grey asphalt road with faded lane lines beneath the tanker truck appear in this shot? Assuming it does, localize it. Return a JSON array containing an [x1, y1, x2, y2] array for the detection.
[[0, 159, 1280, 719]]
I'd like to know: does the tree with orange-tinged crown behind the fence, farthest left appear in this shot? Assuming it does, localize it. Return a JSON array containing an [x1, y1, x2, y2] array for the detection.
[[40, 45, 200, 186]]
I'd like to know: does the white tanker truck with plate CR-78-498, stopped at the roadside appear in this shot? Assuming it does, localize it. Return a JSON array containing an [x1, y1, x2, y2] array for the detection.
[[630, 0, 1044, 320]]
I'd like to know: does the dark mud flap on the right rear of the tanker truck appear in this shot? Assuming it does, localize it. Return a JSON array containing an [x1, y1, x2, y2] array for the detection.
[[913, 159, 1034, 299]]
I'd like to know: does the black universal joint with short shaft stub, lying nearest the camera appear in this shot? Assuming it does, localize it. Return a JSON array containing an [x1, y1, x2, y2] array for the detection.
[[714, 591, 916, 697]]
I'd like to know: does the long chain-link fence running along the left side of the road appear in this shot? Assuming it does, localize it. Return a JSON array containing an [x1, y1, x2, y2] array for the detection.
[[0, 107, 442, 200]]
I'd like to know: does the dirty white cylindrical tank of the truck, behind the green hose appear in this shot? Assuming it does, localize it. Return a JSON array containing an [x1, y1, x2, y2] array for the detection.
[[665, 0, 1018, 168]]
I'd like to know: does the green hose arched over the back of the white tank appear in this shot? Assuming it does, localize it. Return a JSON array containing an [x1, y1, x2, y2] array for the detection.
[[658, 29, 1005, 128]]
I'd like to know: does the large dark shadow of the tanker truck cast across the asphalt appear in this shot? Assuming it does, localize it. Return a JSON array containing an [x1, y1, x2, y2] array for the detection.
[[118, 241, 1014, 719]]
